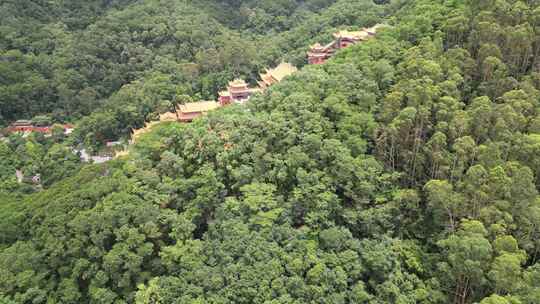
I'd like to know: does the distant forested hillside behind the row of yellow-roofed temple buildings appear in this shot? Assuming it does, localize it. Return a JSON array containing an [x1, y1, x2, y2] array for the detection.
[[0, 0, 383, 148]]
